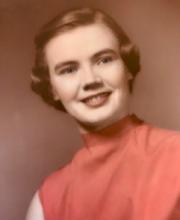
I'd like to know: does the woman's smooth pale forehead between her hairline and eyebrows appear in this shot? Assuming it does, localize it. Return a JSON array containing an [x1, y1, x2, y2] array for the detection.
[[45, 23, 119, 62]]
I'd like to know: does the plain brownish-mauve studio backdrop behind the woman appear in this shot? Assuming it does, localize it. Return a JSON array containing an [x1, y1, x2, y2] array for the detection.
[[0, 0, 180, 220]]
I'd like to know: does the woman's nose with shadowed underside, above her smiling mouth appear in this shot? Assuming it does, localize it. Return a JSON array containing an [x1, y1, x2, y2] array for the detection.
[[81, 66, 103, 91]]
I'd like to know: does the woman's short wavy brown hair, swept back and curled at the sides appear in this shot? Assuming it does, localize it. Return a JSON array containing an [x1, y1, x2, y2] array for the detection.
[[31, 8, 140, 111]]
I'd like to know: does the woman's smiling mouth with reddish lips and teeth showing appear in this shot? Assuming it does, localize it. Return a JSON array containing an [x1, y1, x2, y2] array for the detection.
[[81, 92, 111, 108]]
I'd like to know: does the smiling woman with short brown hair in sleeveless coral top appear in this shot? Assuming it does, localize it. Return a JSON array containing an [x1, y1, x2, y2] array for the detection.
[[27, 8, 180, 220]]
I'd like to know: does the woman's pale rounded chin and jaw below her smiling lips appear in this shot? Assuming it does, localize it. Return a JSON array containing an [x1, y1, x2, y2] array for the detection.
[[67, 93, 127, 130]]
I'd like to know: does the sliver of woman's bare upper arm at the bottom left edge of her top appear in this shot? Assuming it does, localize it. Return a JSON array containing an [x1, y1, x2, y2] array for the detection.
[[26, 192, 45, 220]]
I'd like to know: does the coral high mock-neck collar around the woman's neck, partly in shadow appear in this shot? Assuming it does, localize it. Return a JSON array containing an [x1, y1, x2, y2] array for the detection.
[[81, 114, 143, 147]]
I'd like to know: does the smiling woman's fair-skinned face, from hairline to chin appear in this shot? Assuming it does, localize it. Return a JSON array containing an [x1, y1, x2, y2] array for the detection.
[[45, 23, 130, 129]]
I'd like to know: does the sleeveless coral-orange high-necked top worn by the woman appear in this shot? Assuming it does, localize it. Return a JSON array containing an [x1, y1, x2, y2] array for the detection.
[[39, 116, 180, 220]]
